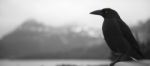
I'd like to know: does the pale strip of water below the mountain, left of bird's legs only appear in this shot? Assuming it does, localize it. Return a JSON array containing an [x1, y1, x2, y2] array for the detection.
[[0, 60, 110, 66]]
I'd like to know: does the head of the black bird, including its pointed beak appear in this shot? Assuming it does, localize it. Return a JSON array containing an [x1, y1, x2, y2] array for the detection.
[[90, 8, 119, 18]]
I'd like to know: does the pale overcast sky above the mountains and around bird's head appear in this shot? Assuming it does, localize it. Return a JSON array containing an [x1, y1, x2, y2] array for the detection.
[[0, 0, 150, 37]]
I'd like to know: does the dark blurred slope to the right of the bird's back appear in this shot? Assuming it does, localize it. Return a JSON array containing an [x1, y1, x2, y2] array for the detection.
[[133, 19, 150, 59]]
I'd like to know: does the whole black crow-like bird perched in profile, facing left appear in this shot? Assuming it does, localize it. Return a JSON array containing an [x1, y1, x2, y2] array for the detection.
[[90, 8, 144, 66]]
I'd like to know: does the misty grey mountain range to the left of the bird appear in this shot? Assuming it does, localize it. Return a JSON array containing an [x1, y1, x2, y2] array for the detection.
[[0, 19, 110, 59]]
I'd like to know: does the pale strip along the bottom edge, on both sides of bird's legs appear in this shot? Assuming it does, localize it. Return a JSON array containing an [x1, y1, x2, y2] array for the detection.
[[0, 59, 150, 66]]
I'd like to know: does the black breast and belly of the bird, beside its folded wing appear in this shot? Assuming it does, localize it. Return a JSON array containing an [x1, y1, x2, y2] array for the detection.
[[102, 19, 130, 53]]
